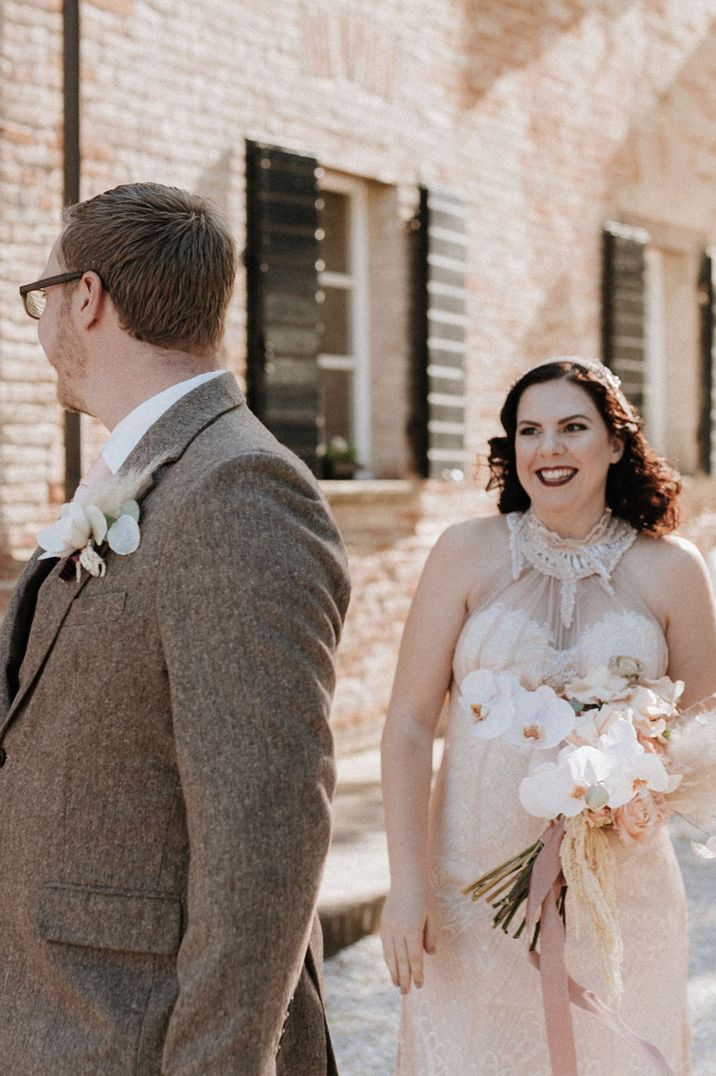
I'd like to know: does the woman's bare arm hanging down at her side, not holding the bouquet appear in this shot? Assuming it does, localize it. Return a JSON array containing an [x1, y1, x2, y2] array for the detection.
[[381, 523, 476, 993]]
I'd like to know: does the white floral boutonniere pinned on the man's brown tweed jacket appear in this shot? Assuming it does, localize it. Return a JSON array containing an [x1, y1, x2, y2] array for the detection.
[[38, 464, 157, 581]]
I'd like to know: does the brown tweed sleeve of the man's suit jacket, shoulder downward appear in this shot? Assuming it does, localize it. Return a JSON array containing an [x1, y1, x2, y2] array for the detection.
[[157, 453, 348, 1076]]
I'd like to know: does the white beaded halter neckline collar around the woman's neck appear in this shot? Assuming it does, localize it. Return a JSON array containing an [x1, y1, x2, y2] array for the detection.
[[507, 508, 636, 627]]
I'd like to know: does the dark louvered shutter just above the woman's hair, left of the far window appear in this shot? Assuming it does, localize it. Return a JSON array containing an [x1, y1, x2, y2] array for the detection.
[[602, 222, 649, 411]]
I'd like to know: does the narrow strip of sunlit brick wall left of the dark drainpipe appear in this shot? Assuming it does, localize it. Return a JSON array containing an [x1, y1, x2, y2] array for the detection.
[[0, 0, 62, 575]]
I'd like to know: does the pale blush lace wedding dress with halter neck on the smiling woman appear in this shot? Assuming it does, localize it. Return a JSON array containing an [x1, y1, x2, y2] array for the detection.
[[397, 511, 689, 1076]]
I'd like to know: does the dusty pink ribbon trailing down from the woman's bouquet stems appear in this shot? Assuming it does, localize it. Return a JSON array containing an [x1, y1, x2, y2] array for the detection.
[[527, 819, 676, 1076]]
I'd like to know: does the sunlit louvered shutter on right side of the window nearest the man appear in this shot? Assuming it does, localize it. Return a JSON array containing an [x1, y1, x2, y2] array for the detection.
[[410, 188, 467, 479]]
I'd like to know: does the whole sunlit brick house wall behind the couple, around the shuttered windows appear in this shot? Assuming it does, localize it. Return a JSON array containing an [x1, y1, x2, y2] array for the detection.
[[0, 0, 716, 748]]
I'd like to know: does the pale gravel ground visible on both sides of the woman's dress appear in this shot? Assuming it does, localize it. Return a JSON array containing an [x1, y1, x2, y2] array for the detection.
[[325, 834, 716, 1076]]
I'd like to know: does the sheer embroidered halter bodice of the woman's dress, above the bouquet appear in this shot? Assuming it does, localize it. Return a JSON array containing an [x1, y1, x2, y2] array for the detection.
[[453, 510, 666, 686]]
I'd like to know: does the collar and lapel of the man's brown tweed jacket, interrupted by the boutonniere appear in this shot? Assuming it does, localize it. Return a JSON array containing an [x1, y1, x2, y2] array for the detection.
[[0, 372, 244, 736]]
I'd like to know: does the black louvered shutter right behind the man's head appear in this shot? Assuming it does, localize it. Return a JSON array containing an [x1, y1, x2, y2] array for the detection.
[[244, 142, 320, 471]]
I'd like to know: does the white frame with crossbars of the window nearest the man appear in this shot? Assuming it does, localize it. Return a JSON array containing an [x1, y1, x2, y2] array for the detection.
[[319, 173, 373, 478]]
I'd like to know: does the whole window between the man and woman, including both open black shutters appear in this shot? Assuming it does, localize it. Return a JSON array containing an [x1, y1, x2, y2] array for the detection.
[[244, 141, 467, 480]]
